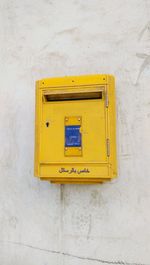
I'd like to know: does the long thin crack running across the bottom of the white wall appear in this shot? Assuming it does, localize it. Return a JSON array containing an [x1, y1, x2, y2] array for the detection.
[[0, 241, 150, 265]]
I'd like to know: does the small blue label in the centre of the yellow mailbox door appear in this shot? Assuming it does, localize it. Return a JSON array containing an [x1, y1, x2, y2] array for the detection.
[[65, 125, 81, 147]]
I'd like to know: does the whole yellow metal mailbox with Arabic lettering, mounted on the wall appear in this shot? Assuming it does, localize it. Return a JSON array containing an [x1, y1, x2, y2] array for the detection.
[[35, 74, 117, 184]]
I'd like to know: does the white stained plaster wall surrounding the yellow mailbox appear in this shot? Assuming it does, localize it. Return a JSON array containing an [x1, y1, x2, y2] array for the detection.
[[0, 0, 150, 265]]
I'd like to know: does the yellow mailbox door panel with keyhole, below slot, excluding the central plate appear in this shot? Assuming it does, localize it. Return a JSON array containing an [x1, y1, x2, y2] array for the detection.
[[40, 96, 107, 163]]
